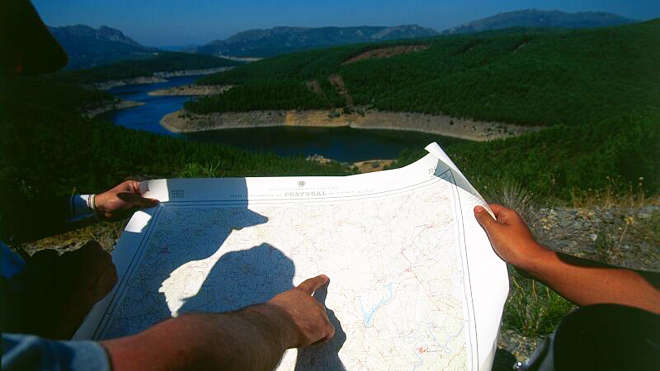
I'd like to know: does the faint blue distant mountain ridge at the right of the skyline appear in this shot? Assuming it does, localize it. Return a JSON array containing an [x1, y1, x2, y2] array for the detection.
[[442, 9, 636, 35]]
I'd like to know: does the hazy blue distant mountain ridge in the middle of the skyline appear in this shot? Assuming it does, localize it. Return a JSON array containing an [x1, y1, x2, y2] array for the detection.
[[194, 25, 438, 57]]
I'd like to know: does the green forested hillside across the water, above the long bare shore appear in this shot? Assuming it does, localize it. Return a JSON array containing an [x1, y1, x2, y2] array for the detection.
[[191, 20, 660, 129]]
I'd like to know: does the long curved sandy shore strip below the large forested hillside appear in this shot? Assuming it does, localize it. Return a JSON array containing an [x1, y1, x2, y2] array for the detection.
[[160, 110, 540, 141]]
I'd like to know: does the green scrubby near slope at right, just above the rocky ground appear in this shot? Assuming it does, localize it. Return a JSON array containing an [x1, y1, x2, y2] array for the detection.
[[393, 109, 660, 203]]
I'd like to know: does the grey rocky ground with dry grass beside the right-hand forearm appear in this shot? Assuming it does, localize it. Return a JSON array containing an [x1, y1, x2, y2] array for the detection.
[[498, 200, 660, 370]]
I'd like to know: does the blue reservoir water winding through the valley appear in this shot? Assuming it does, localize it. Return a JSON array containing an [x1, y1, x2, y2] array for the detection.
[[101, 76, 464, 162]]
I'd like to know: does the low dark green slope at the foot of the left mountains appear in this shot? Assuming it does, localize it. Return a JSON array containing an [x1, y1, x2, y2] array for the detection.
[[55, 52, 240, 84]]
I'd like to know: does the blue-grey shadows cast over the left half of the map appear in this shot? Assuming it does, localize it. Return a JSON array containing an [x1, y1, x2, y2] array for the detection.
[[128, 179, 346, 371]]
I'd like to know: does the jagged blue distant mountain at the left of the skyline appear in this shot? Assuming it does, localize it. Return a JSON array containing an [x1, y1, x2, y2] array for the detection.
[[48, 25, 158, 69]]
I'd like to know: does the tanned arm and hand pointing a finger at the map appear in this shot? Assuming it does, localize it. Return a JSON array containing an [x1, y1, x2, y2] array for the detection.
[[101, 275, 335, 371]]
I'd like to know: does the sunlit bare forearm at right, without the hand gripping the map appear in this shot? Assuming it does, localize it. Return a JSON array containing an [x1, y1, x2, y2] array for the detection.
[[520, 249, 660, 313]]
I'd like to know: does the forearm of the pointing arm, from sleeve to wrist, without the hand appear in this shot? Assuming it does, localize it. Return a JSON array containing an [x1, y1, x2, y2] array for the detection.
[[102, 304, 294, 371]]
